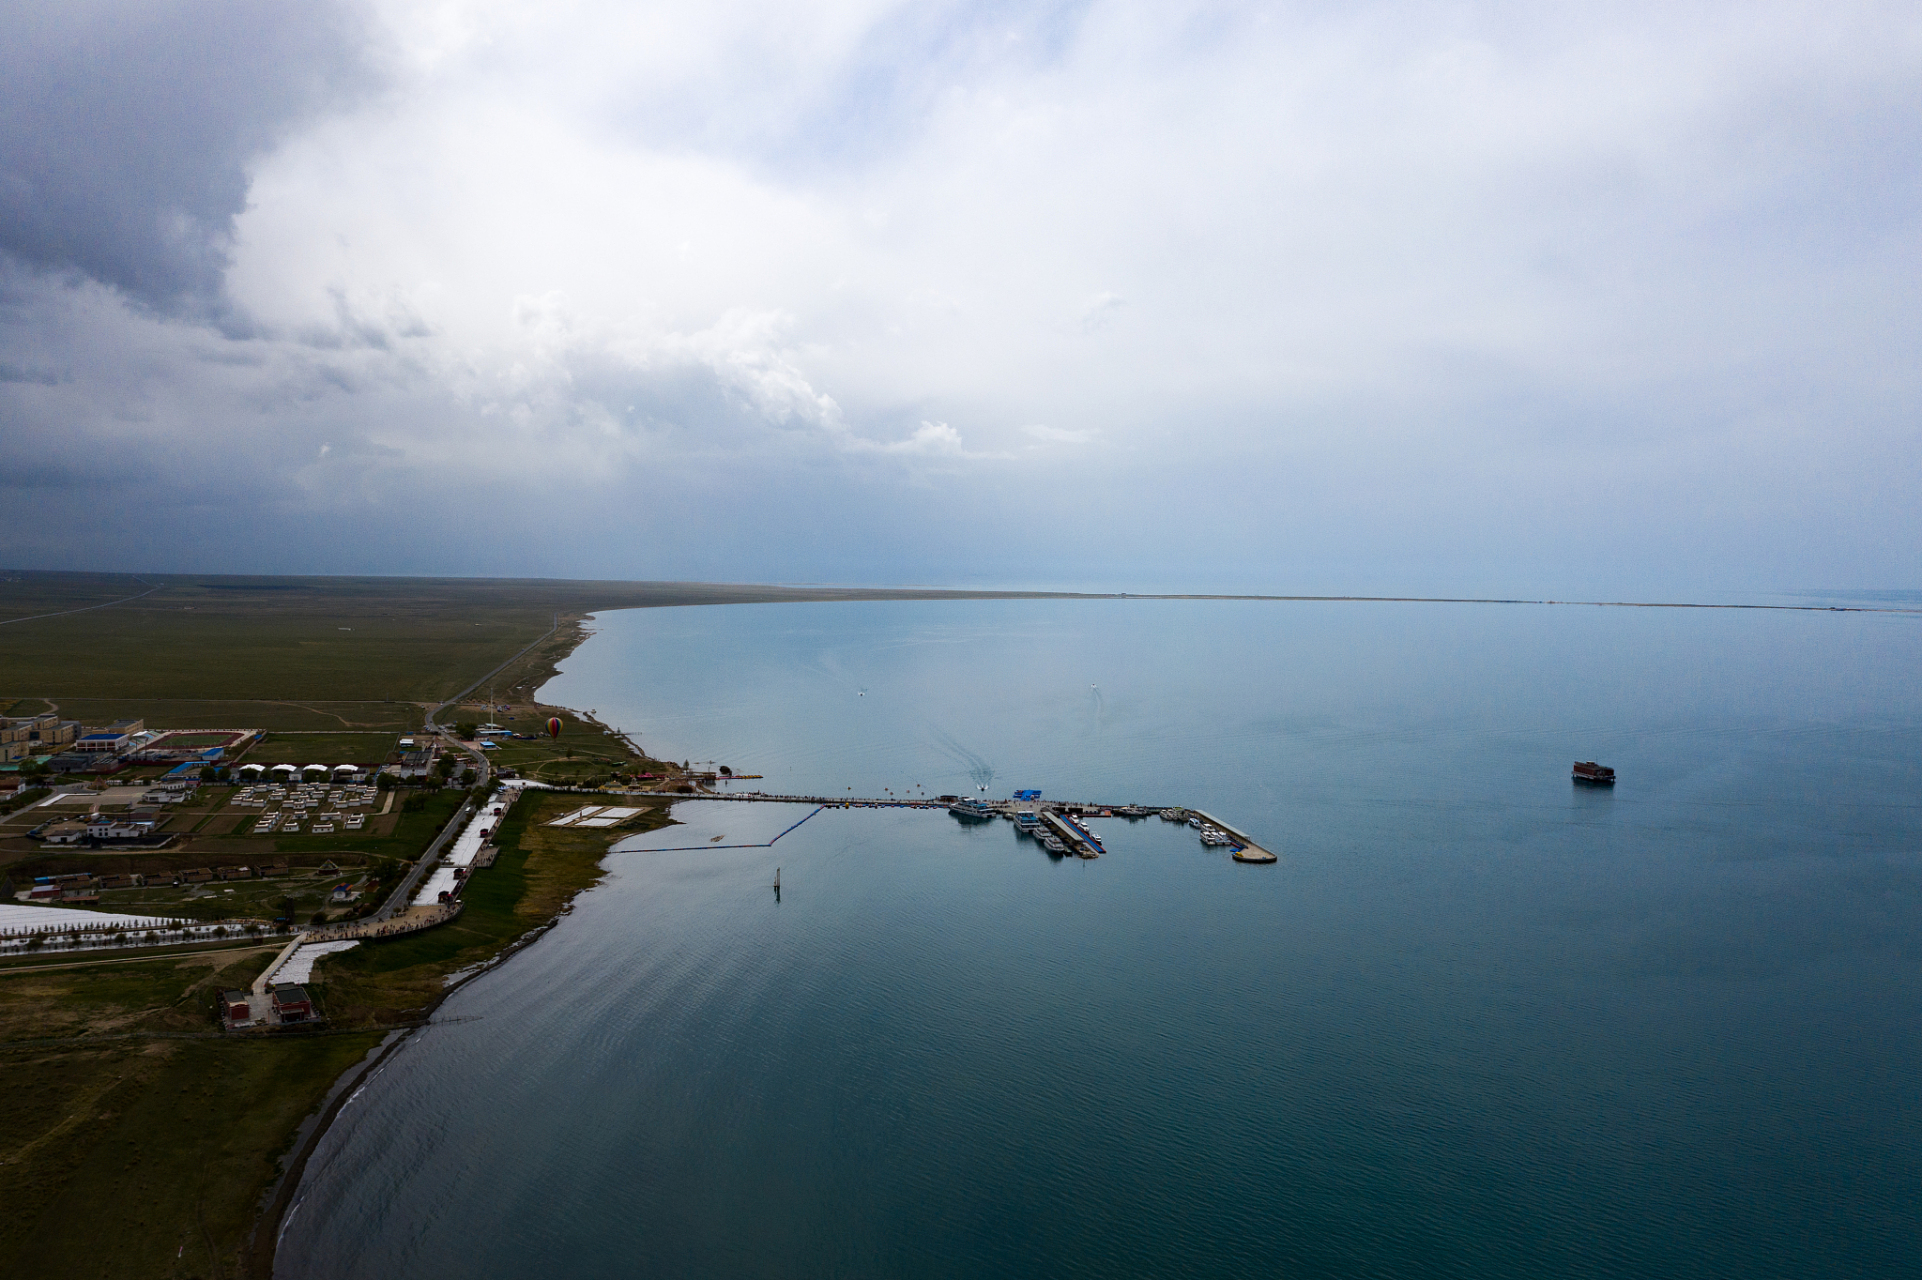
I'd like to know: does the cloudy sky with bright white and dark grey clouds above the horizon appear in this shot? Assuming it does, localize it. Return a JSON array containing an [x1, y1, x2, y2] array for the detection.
[[0, 0, 1922, 596]]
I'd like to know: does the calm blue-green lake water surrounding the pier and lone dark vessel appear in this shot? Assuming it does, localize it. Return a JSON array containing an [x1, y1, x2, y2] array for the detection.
[[279, 602, 1922, 1280]]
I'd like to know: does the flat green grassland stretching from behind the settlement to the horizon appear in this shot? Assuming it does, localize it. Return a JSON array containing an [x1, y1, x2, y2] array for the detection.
[[0, 573, 1068, 711]]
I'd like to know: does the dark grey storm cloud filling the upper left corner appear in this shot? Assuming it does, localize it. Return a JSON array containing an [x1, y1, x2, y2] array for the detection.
[[0, 0, 371, 309]]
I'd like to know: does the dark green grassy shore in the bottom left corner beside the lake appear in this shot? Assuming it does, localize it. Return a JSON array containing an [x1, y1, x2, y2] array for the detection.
[[0, 948, 381, 1276]]
